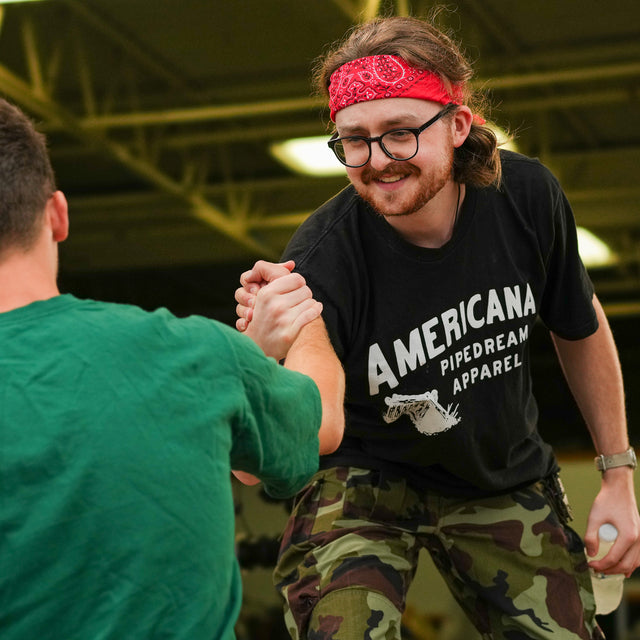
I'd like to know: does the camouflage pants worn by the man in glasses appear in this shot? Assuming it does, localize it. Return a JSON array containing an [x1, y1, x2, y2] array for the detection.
[[274, 467, 604, 640]]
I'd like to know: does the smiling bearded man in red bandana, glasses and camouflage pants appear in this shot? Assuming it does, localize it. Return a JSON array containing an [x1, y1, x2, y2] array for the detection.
[[236, 18, 640, 640]]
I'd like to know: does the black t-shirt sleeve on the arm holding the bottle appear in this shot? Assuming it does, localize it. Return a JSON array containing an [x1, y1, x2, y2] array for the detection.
[[540, 170, 598, 340]]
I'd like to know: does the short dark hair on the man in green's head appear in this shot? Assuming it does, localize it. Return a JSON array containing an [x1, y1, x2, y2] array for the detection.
[[0, 98, 55, 253]]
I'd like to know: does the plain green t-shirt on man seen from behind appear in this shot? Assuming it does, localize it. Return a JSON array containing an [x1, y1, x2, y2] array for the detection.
[[0, 295, 321, 640]]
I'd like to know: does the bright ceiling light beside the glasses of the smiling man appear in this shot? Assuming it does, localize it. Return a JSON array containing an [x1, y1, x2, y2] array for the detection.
[[271, 136, 346, 176]]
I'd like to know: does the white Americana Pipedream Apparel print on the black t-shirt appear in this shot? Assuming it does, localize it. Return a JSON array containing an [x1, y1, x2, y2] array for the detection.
[[368, 284, 537, 435]]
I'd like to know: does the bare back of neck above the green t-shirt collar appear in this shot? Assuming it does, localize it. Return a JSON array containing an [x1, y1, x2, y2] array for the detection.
[[0, 250, 60, 313]]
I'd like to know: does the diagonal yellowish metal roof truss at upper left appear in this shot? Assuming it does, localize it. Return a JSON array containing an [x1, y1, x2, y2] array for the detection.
[[0, 0, 277, 258]]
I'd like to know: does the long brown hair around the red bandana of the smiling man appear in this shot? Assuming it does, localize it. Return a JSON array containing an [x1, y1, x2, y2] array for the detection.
[[313, 17, 501, 187]]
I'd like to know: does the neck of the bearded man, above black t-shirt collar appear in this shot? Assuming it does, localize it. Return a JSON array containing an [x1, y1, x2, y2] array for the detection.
[[385, 180, 466, 249]]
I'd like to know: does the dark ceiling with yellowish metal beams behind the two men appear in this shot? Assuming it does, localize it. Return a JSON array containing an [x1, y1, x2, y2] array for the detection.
[[0, 0, 640, 313]]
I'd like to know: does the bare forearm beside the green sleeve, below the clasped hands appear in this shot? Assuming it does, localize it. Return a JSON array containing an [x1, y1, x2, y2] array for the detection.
[[285, 318, 345, 455]]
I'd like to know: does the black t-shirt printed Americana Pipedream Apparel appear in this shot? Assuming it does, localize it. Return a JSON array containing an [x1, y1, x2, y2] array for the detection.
[[284, 152, 597, 495]]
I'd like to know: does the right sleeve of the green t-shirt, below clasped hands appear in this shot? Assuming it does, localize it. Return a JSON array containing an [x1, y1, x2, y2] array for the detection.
[[230, 334, 322, 498]]
